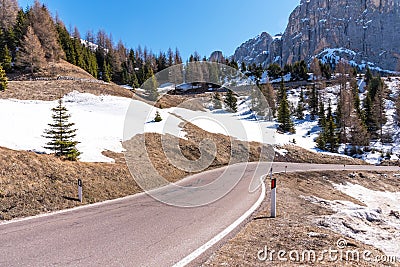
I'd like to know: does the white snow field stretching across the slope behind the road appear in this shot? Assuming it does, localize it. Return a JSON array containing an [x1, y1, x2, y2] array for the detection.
[[0, 78, 400, 164]]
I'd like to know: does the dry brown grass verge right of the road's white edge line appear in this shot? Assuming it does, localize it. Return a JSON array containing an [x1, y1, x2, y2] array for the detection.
[[203, 171, 400, 266]]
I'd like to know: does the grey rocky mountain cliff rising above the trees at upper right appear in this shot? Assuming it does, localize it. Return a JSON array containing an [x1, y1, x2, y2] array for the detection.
[[234, 0, 400, 70]]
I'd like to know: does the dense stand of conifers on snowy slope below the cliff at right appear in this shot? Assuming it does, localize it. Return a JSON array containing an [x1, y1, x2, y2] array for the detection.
[[252, 59, 400, 155]]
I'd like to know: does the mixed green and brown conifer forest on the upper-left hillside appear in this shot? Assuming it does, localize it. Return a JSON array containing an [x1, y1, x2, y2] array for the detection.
[[0, 0, 186, 87]]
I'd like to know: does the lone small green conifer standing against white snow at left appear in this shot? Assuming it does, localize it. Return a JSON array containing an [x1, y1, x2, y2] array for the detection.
[[44, 99, 81, 161]]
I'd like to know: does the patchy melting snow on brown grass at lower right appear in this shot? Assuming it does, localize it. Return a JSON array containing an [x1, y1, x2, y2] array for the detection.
[[306, 183, 400, 259]]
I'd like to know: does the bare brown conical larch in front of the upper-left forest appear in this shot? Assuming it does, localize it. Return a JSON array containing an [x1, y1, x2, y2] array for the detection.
[[16, 26, 46, 74]]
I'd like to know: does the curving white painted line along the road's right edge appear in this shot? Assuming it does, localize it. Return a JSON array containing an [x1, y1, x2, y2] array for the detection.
[[173, 175, 266, 267]]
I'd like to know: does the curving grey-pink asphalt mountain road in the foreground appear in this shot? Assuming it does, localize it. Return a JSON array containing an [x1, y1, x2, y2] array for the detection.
[[0, 163, 400, 266]]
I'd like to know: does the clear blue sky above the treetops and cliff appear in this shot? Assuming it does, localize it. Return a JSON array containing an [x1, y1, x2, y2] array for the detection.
[[18, 0, 300, 59]]
